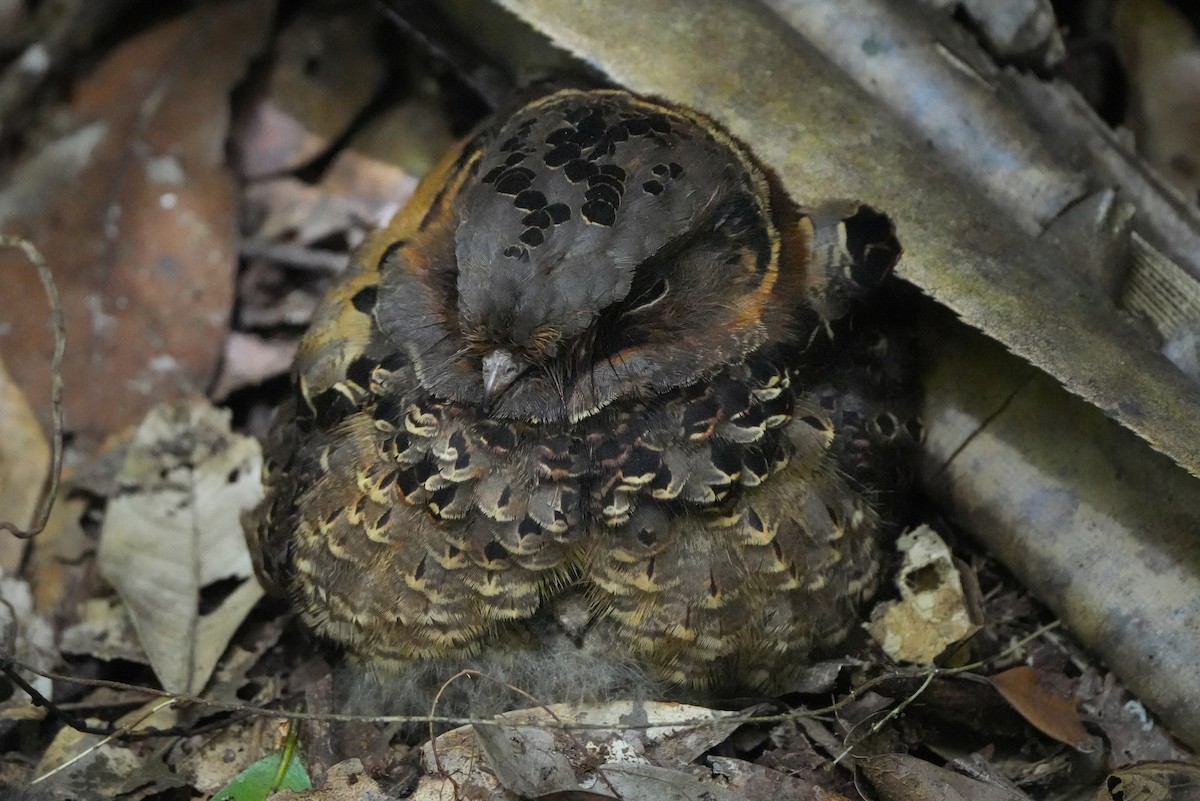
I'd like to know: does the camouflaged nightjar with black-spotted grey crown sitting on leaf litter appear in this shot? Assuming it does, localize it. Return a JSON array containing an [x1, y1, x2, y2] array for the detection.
[[250, 91, 913, 687]]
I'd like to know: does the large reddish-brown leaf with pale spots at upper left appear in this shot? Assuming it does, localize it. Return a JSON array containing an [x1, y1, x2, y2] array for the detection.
[[0, 0, 272, 448]]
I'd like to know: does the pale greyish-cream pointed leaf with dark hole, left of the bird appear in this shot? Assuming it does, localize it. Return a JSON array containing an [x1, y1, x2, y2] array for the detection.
[[98, 401, 263, 693]]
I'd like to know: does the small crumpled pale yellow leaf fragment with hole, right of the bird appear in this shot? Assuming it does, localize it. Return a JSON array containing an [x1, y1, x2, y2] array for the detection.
[[868, 525, 979, 664]]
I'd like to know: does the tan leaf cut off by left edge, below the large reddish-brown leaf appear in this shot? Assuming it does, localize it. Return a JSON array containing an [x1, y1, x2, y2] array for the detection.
[[0, 350, 50, 574]]
